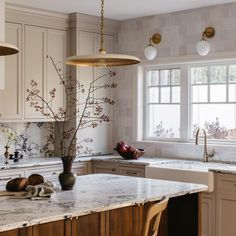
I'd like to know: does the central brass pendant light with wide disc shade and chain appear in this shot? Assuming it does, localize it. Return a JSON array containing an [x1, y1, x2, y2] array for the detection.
[[66, 0, 140, 67]]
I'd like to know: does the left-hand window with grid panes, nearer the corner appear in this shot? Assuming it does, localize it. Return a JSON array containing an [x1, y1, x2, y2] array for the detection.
[[146, 68, 180, 138]]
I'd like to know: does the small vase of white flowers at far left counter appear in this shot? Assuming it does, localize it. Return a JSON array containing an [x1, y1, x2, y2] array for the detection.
[[1, 128, 16, 164]]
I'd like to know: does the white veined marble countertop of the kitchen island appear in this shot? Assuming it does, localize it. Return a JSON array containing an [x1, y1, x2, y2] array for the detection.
[[0, 174, 207, 232]]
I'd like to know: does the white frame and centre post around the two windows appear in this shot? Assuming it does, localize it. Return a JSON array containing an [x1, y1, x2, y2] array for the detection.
[[142, 59, 236, 146]]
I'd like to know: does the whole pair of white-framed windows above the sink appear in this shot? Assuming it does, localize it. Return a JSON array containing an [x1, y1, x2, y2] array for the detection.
[[143, 61, 236, 142]]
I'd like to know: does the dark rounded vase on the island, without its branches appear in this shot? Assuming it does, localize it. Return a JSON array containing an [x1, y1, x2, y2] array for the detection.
[[59, 156, 76, 190]]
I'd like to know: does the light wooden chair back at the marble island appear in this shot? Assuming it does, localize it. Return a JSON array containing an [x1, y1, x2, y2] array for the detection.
[[142, 198, 169, 236]]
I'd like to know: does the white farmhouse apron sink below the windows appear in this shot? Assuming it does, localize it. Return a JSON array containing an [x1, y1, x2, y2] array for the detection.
[[145, 161, 217, 192]]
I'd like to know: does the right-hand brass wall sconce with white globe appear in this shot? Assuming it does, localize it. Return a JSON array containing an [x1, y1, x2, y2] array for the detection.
[[196, 27, 215, 56]]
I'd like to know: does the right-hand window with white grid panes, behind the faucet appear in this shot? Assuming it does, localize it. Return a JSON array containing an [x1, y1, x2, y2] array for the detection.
[[191, 64, 236, 140]]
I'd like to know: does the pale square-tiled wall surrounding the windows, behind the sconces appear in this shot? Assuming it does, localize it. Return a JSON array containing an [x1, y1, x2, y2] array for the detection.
[[115, 3, 236, 161]]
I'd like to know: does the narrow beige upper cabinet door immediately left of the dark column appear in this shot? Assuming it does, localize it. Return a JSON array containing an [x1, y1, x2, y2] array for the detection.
[[45, 29, 67, 118]]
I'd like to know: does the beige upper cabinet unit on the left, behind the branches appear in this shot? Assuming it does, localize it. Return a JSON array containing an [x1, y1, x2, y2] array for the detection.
[[0, 7, 69, 122]]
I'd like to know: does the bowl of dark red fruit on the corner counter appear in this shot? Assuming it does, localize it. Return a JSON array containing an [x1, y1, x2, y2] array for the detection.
[[114, 141, 146, 159]]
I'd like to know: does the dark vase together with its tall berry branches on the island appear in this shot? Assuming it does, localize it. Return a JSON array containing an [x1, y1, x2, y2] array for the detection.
[[26, 57, 117, 190]]
